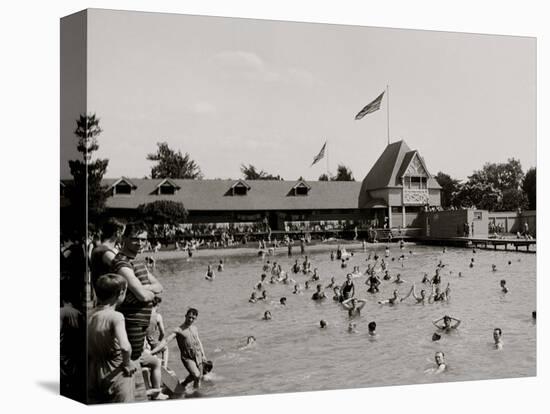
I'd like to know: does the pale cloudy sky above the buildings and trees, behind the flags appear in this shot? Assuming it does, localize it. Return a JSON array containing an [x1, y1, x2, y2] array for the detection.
[[61, 10, 536, 180]]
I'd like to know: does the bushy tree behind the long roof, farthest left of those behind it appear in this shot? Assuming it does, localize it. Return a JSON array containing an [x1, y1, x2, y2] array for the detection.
[[147, 142, 202, 180]]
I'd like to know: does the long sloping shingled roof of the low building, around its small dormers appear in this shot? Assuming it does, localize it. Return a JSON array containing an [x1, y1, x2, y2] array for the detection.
[[99, 179, 361, 211]]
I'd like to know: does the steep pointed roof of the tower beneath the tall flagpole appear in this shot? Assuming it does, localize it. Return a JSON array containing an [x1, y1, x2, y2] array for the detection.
[[363, 140, 441, 190]]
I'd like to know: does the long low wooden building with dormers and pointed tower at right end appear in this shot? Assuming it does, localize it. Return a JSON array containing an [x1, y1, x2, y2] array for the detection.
[[66, 141, 440, 230]]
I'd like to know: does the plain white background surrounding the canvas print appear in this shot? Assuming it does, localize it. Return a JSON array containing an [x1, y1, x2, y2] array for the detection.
[[0, 0, 550, 413]]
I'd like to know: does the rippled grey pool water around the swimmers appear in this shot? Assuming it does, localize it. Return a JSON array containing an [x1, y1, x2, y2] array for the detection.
[[150, 244, 536, 396]]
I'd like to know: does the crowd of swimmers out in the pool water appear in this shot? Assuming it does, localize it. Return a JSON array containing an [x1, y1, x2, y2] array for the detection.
[[236, 241, 536, 373]]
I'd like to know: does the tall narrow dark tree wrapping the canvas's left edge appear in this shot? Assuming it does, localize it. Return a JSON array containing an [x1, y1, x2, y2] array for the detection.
[[67, 114, 109, 224]]
